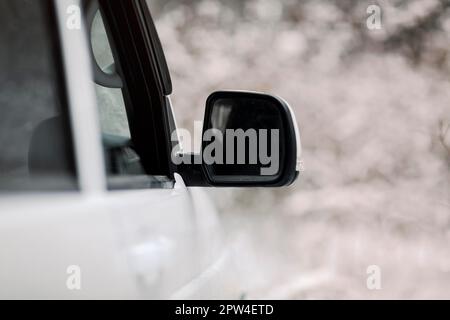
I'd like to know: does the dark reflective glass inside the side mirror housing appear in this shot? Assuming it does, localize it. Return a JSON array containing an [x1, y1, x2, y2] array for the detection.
[[203, 94, 284, 182]]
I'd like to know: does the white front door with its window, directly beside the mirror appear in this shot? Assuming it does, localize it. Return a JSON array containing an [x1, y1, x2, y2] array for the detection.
[[88, 1, 213, 298]]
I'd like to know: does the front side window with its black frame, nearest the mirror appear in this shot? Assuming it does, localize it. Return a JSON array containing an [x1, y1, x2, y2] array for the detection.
[[83, 0, 174, 190]]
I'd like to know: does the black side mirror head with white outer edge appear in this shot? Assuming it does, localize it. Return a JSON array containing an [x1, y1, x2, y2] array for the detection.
[[187, 91, 300, 187]]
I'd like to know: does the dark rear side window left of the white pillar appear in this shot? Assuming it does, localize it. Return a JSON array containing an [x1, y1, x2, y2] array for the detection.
[[0, 0, 76, 192]]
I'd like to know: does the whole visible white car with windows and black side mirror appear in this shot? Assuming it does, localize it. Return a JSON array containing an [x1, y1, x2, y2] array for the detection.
[[0, 0, 300, 299]]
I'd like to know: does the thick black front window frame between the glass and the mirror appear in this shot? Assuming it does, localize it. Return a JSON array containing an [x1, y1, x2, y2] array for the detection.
[[99, 0, 175, 190]]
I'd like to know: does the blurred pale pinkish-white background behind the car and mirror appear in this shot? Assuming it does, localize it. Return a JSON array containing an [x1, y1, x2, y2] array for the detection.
[[148, 0, 450, 299]]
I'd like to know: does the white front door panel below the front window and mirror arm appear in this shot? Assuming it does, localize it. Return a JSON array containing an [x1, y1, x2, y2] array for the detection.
[[108, 175, 199, 299]]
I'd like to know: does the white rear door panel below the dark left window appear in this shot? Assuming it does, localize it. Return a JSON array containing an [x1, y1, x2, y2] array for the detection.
[[0, 194, 139, 299]]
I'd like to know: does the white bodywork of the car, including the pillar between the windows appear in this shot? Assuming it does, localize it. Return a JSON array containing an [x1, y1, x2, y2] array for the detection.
[[0, 0, 238, 299]]
